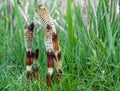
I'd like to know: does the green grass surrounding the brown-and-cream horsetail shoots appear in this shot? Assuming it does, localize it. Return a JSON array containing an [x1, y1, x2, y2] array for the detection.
[[0, 0, 120, 91]]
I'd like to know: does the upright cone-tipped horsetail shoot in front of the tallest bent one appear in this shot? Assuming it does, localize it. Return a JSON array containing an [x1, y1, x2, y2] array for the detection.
[[45, 25, 54, 87]]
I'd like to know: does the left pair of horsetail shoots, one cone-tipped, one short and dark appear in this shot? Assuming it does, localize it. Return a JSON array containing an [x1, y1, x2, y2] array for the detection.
[[24, 23, 39, 84]]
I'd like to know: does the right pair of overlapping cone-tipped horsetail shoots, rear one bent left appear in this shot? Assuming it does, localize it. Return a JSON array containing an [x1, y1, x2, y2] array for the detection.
[[38, 5, 62, 87]]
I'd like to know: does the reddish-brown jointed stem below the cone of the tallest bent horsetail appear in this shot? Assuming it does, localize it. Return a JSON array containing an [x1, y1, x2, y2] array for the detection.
[[52, 33, 62, 80]]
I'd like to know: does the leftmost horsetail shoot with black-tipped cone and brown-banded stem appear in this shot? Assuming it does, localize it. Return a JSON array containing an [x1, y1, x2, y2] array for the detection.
[[24, 23, 34, 84]]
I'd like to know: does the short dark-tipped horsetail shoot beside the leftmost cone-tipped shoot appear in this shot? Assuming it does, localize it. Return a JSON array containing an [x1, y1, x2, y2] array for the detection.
[[32, 49, 39, 80]]
